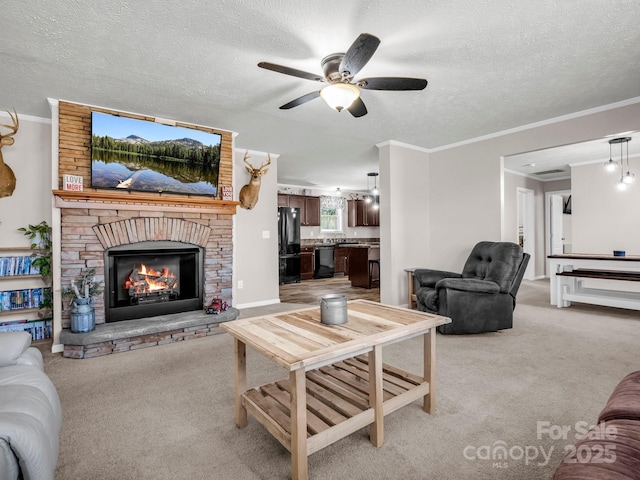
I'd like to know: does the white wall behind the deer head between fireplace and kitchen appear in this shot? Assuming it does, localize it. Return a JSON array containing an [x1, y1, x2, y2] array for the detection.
[[233, 150, 280, 308]]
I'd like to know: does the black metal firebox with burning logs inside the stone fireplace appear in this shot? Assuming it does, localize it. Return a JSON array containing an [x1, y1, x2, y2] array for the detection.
[[105, 241, 204, 322]]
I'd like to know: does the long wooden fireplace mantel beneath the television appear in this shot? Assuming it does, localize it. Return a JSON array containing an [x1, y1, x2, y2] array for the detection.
[[52, 190, 240, 215]]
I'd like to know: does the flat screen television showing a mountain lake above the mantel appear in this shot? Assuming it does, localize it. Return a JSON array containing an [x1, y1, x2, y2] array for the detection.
[[91, 112, 222, 197]]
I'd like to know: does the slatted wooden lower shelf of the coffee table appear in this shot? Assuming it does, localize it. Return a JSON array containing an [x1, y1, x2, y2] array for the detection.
[[242, 355, 429, 455]]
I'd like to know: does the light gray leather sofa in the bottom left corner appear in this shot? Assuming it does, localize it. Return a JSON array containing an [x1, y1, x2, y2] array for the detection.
[[0, 332, 62, 480]]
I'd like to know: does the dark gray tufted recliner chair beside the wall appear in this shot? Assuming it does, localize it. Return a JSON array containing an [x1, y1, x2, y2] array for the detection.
[[414, 242, 529, 334]]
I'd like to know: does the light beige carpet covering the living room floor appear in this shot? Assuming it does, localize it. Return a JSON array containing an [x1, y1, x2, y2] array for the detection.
[[45, 281, 640, 480]]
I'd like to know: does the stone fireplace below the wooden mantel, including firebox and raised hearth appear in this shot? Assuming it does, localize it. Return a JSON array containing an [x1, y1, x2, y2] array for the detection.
[[57, 204, 237, 358]]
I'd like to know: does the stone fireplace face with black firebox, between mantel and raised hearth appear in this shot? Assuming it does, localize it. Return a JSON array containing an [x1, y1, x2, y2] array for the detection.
[[61, 202, 233, 328]]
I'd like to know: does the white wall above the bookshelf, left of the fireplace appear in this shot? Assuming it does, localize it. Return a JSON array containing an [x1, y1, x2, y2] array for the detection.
[[0, 112, 52, 247]]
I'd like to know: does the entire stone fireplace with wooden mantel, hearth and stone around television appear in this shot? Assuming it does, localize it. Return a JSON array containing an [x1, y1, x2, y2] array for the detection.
[[53, 102, 239, 358]]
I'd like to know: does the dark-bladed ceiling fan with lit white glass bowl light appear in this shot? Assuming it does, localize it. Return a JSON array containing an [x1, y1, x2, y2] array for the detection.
[[258, 33, 427, 117]]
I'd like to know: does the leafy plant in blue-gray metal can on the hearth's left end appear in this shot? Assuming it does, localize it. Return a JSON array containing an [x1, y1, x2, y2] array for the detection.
[[62, 268, 102, 333]]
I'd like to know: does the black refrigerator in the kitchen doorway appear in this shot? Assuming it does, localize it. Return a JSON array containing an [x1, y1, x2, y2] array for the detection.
[[278, 207, 300, 283]]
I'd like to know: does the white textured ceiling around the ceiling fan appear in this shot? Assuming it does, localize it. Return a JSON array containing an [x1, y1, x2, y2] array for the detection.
[[0, 0, 640, 189]]
